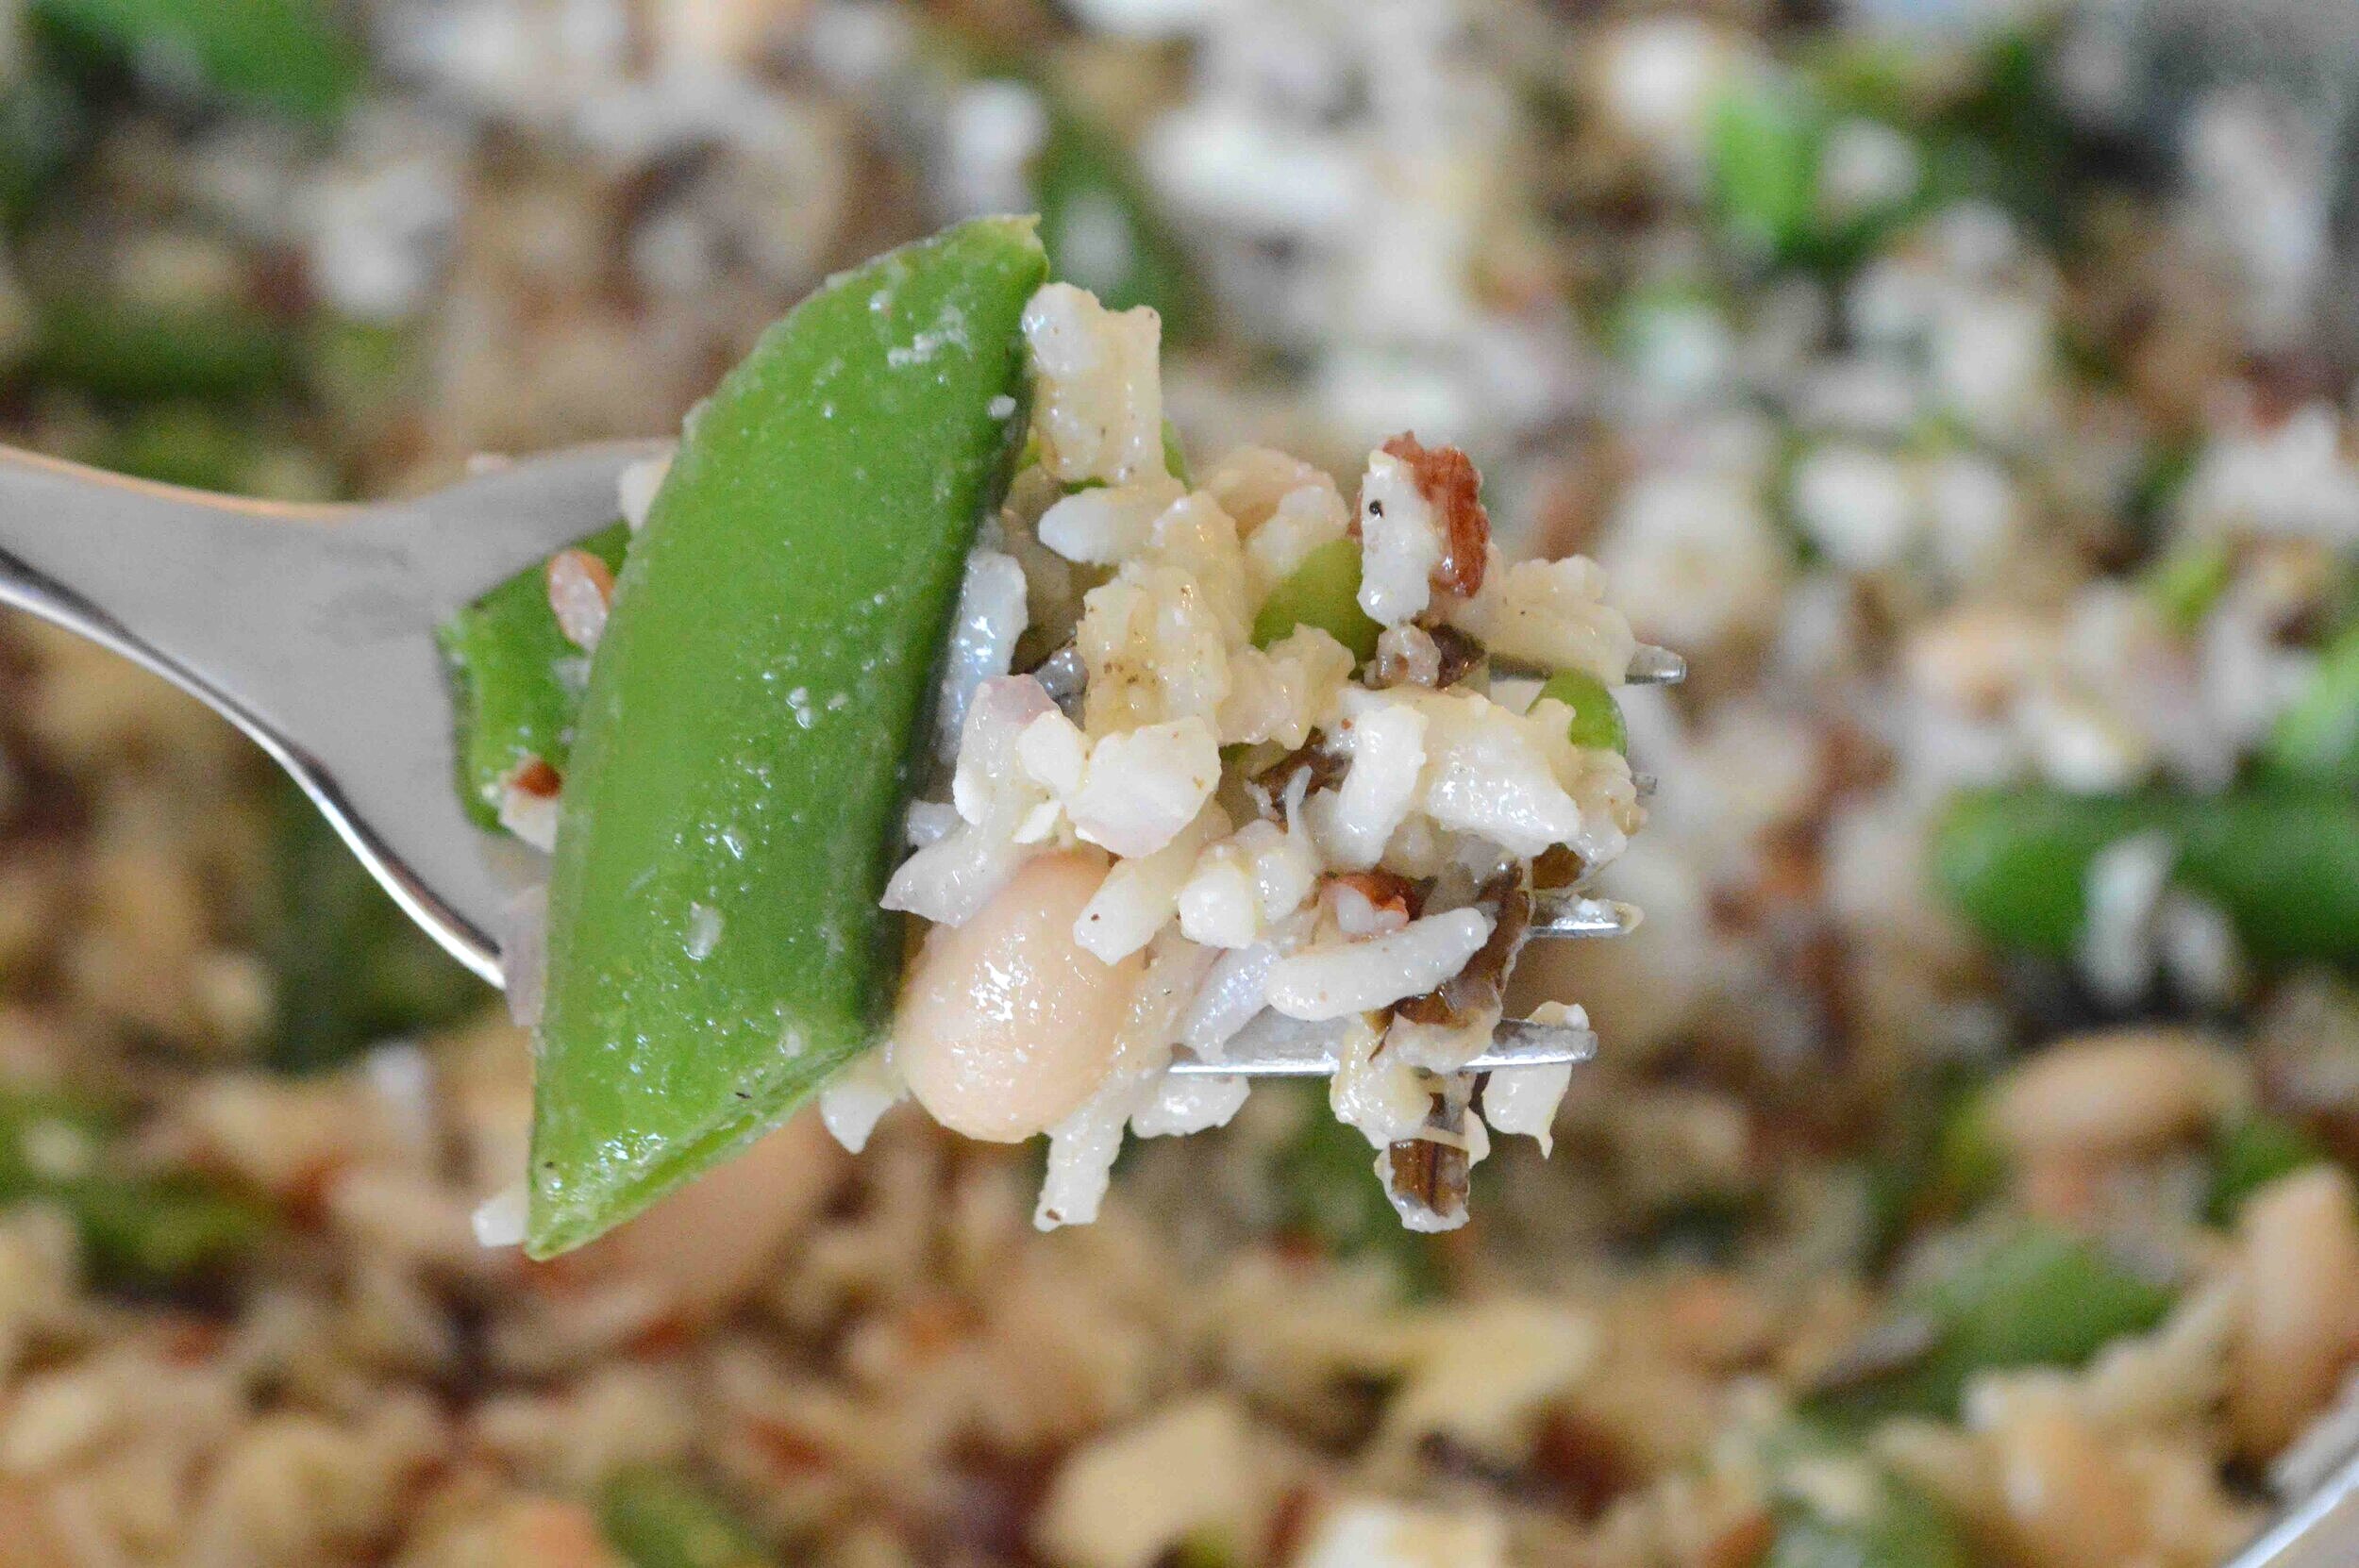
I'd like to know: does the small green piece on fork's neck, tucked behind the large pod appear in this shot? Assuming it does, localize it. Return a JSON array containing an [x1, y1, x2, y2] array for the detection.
[[439, 524, 630, 827]]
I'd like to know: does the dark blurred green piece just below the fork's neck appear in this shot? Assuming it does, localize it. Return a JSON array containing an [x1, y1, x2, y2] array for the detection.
[[264, 778, 491, 1073]]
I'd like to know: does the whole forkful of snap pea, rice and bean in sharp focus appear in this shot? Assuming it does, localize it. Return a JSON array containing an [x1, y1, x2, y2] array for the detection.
[[446, 219, 1645, 1255]]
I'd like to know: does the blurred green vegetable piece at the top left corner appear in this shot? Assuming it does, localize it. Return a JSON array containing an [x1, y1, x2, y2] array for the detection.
[[33, 0, 361, 120]]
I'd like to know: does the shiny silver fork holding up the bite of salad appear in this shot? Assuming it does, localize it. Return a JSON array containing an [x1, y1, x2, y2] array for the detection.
[[0, 441, 1687, 1076]]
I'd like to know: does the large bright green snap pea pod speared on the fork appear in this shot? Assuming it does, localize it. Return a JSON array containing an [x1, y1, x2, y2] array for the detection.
[[540, 219, 1047, 1257]]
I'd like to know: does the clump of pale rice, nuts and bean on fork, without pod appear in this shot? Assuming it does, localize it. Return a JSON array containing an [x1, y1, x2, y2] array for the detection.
[[868, 283, 1645, 1228]]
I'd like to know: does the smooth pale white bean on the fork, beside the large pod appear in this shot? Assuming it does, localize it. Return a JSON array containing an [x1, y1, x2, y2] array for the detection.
[[895, 851, 1145, 1143]]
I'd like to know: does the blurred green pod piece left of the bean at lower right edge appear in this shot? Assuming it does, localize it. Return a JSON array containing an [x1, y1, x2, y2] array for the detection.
[[1810, 1224, 2173, 1422]]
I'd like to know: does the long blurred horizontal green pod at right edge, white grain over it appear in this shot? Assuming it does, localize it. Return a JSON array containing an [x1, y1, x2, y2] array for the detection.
[[1932, 785, 2359, 964]]
